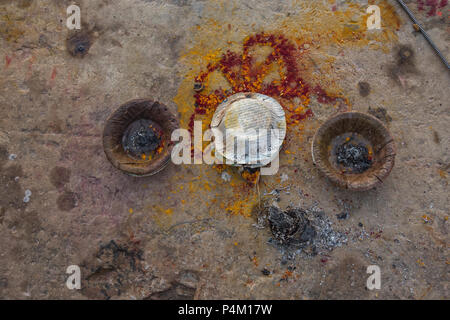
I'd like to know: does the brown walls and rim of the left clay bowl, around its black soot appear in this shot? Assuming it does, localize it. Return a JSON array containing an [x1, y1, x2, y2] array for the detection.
[[103, 99, 179, 177]]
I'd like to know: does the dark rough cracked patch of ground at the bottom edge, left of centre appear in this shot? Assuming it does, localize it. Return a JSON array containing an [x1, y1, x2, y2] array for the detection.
[[80, 239, 200, 300]]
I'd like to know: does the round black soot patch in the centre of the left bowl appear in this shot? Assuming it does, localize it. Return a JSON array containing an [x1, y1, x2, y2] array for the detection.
[[122, 119, 162, 159]]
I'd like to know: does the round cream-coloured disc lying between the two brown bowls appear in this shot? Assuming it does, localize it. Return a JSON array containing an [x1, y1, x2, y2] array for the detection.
[[211, 93, 286, 167]]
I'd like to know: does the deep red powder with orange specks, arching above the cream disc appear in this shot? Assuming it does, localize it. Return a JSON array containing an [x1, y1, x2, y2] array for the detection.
[[188, 33, 336, 132]]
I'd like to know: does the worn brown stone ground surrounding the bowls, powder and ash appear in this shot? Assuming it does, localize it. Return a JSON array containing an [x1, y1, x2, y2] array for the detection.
[[0, 0, 450, 299]]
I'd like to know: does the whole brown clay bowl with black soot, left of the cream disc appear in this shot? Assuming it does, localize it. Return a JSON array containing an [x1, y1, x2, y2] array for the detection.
[[103, 99, 178, 177]]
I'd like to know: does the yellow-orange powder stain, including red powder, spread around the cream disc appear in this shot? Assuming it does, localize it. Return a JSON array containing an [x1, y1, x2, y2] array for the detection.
[[169, 0, 401, 216]]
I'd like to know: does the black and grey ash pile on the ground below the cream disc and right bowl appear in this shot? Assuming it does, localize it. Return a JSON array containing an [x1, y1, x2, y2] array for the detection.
[[258, 205, 348, 258]]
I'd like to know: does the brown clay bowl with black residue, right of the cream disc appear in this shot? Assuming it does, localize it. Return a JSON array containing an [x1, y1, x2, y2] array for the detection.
[[312, 112, 395, 191]]
